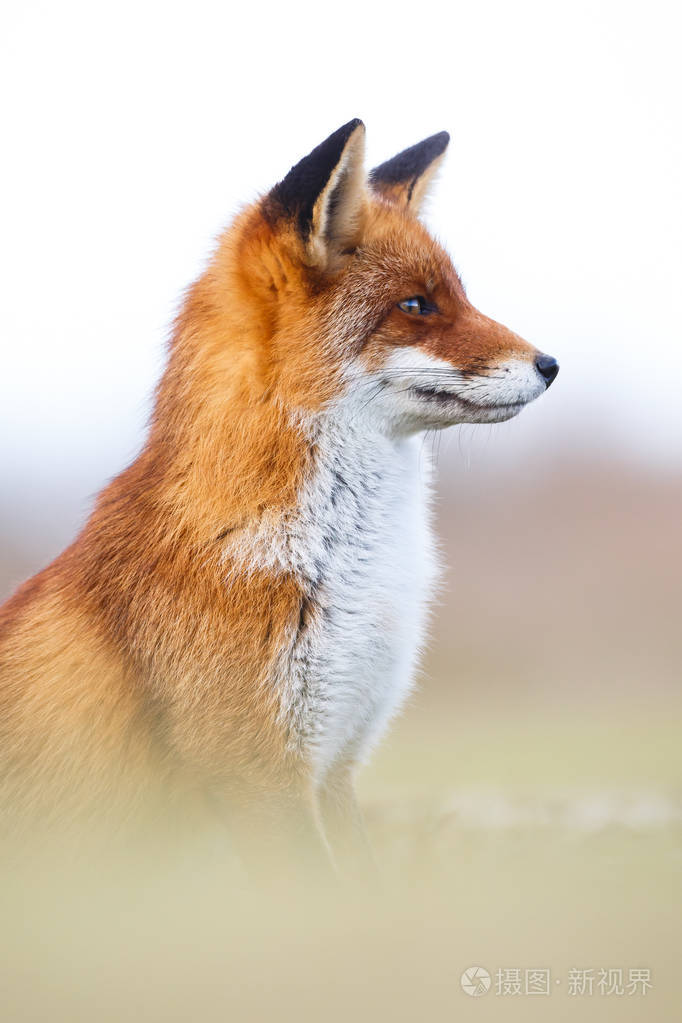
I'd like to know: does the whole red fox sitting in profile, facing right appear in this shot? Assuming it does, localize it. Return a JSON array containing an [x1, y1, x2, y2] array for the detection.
[[0, 120, 558, 863]]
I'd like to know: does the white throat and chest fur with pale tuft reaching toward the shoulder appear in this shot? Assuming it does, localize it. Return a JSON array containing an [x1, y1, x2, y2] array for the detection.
[[221, 390, 436, 782]]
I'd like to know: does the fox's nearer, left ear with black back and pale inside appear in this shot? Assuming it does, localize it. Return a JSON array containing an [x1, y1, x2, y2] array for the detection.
[[264, 118, 366, 270]]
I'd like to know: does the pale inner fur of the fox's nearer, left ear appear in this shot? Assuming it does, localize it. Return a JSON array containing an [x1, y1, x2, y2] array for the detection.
[[308, 125, 366, 270]]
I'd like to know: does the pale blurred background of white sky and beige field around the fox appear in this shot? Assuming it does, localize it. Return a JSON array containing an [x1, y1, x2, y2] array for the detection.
[[0, 0, 682, 1020]]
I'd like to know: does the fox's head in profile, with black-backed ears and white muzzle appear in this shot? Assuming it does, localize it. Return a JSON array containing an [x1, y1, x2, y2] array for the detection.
[[209, 121, 558, 433]]
